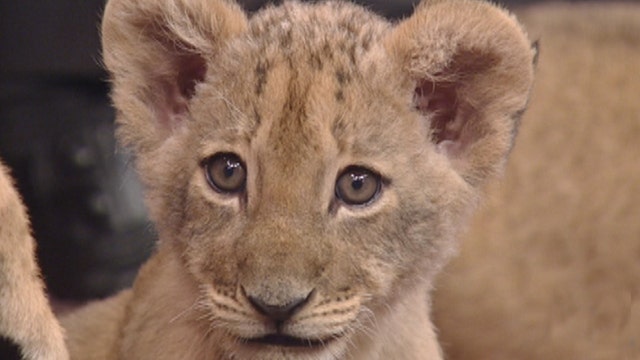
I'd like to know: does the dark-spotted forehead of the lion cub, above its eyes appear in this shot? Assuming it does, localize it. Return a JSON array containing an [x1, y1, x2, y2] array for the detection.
[[191, 2, 410, 160]]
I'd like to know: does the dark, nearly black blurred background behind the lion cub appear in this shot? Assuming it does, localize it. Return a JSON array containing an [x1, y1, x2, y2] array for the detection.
[[0, 0, 604, 359]]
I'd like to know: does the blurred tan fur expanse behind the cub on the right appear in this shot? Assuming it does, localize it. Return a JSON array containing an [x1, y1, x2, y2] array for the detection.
[[435, 3, 640, 360]]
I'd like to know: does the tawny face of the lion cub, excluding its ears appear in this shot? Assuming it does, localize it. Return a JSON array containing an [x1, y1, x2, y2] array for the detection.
[[161, 8, 466, 356]]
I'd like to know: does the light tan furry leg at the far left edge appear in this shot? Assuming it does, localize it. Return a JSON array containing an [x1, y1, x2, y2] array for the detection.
[[0, 163, 69, 360]]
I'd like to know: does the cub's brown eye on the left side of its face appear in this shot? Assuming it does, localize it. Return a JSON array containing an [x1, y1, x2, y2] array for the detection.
[[204, 153, 247, 193]]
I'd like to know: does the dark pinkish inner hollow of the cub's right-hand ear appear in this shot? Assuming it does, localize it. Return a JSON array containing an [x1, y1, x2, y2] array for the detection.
[[414, 80, 464, 146]]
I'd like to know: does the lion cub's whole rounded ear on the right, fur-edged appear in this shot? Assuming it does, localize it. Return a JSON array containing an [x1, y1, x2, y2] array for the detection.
[[384, 0, 535, 185]]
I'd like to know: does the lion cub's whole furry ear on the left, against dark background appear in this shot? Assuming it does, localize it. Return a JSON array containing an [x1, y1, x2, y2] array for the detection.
[[102, 0, 247, 153]]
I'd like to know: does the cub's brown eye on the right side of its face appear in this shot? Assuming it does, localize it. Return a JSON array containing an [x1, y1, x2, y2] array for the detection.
[[336, 166, 382, 205]]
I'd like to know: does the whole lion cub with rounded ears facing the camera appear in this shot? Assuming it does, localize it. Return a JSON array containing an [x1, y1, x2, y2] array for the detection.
[[3, 0, 535, 360]]
